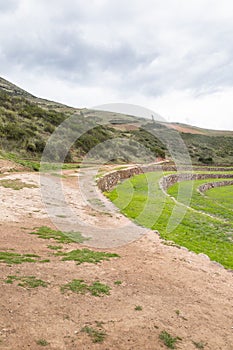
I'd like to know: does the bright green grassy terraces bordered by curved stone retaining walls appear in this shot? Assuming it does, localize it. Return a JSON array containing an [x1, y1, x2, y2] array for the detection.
[[106, 173, 233, 269]]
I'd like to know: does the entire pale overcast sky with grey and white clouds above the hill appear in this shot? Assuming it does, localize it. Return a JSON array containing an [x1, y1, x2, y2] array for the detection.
[[0, 0, 233, 130]]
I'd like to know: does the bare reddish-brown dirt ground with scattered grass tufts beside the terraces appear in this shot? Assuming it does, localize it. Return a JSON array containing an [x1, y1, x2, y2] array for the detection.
[[0, 165, 233, 350]]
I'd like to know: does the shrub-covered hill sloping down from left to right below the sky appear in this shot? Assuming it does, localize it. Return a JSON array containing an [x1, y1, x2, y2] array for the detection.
[[0, 78, 233, 165]]
